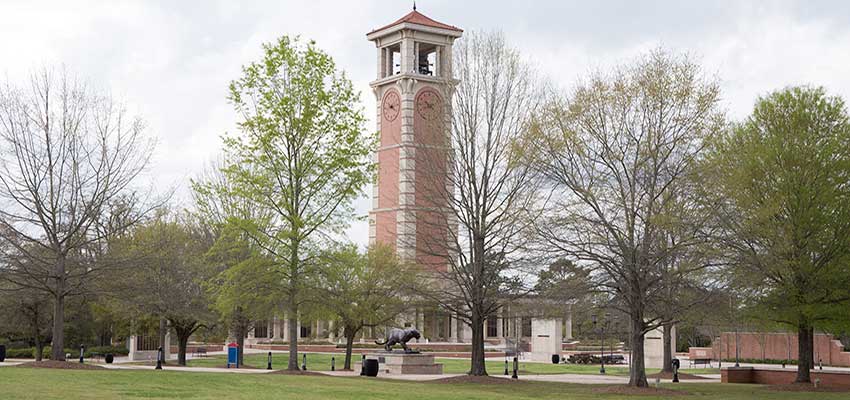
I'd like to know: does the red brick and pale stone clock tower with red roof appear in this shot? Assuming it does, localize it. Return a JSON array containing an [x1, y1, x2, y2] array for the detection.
[[366, 6, 463, 270]]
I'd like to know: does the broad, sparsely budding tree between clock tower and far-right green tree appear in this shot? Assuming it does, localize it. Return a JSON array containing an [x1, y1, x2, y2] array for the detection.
[[532, 51, 723, 386]]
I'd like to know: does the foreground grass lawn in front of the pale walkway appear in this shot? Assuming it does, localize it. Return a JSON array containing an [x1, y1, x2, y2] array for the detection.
[[0, 367, 848, 400]]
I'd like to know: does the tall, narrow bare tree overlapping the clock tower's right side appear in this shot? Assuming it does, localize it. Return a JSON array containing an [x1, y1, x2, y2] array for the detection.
[[416, 33, 542, 375]]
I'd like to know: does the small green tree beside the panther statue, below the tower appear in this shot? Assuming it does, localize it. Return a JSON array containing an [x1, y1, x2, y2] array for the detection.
[[320, 245, 409, 370]]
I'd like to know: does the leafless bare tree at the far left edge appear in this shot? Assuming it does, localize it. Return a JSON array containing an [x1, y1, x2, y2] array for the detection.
[[0, 70, 153, 360]]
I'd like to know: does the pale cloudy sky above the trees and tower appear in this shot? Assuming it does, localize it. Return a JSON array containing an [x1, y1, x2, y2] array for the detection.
[[0, 0, 850, 247]]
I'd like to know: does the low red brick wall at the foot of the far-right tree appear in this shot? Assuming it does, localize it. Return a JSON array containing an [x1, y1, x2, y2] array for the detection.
[[720, 367, 850, 389]]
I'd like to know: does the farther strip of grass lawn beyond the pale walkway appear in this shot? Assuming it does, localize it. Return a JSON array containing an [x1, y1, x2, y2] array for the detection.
[[188, 353, 720, 376]]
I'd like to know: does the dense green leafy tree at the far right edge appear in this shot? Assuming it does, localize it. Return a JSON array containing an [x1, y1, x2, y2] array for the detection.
[[709, 87, 850, 382]]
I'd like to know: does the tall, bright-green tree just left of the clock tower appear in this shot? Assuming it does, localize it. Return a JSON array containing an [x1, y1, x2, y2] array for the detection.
[[219, 37, 375, 370]]
